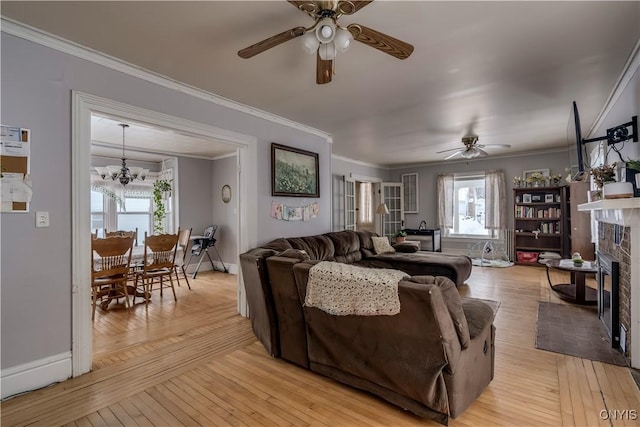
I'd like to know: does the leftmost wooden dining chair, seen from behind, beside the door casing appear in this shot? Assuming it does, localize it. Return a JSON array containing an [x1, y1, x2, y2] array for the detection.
[[91, 236, 134, 320]]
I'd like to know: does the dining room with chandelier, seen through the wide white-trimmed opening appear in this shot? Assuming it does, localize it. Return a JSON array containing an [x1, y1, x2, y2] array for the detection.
[[87, 113, 238, 357]]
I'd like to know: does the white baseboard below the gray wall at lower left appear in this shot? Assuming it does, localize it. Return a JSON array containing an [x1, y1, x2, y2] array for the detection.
[[0, 351, 72, 399]]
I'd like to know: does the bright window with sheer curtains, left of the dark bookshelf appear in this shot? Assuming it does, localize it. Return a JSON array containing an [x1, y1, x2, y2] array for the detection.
[[438, 171, 506, 238]]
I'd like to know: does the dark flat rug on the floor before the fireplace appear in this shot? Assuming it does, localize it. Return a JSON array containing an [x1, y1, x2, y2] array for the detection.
[[536, 302, 628, 366]]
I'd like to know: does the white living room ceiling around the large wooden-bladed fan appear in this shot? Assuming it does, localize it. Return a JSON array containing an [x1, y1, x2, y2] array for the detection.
[[2, 0, 640, 165]]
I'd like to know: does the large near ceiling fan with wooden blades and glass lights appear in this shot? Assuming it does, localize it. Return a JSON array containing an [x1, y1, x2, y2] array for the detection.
[[238, 0, 413, 84]]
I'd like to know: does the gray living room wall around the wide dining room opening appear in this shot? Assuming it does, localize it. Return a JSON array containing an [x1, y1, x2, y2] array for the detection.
[[0, 33, 331, 369]]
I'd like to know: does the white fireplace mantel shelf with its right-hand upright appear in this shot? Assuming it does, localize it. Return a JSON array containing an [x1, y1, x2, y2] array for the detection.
[[578, 197, 640, 368]]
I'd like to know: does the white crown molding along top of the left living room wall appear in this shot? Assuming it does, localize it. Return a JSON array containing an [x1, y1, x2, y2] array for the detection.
[[0, 16, 333, 144]]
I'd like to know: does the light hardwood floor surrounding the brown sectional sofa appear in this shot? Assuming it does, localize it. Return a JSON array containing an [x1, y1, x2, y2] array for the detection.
[[0, 266, 640, 426]]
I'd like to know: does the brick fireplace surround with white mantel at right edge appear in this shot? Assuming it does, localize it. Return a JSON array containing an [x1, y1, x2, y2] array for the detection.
[[578, 197, 640, 368]]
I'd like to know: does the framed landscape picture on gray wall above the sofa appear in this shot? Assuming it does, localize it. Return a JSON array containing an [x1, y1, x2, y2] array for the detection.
[[271, 143, 320, 197]]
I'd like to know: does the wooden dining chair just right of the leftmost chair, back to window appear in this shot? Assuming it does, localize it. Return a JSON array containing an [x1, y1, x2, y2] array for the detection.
[[133, 229, 180, 304]]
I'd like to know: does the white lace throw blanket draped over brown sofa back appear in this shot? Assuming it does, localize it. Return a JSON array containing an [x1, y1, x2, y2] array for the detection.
[[304, 261, 407, 316]]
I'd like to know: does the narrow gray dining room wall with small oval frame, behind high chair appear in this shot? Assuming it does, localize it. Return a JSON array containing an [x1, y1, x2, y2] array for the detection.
[[211, 156, 238, 268]]
